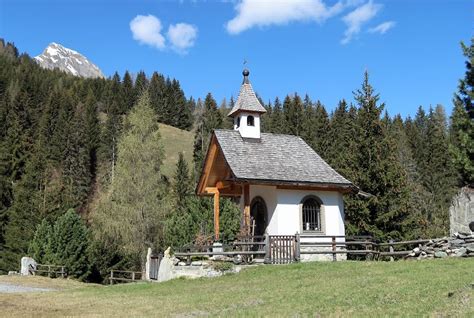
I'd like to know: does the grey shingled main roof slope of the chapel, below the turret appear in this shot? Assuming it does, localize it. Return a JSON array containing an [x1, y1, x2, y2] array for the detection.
[[214, 129, 355, 188]]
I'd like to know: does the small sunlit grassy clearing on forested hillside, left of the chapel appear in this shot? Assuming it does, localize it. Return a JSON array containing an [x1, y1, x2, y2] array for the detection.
[[160, 124, 194, 178]]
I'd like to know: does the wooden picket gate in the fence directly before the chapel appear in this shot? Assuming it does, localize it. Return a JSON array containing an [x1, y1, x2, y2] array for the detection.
[[268, 235, 296, 264]]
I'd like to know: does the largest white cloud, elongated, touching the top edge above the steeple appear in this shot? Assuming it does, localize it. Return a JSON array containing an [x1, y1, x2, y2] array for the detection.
[[226, 0, 344, 34]]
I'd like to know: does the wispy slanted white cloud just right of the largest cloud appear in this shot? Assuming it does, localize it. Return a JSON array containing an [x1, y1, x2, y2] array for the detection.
[[341, 1, 382, 44]]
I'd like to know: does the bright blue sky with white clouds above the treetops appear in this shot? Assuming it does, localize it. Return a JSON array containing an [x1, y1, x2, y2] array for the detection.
[[0, 0, 474, 116]]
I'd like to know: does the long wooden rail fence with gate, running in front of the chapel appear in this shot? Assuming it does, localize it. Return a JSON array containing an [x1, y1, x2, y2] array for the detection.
[[175, 233, 430, 264]]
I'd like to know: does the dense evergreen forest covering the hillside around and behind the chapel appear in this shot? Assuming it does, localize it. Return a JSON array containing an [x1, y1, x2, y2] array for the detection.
[[0, 39, 474, 282]]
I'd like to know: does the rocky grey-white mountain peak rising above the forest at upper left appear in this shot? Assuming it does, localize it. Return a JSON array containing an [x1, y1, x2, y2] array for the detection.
[[35, 42, 104, 78]]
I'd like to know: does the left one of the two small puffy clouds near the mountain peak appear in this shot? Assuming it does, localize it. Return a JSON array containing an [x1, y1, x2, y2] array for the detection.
[[130, 14, 166, 50]]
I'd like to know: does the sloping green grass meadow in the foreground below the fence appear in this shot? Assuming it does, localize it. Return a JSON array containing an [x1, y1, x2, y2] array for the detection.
[[0, 259, 474, 317]]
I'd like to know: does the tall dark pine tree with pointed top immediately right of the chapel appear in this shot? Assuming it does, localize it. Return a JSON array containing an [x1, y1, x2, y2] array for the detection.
[[346, 72, 409, 239]]
